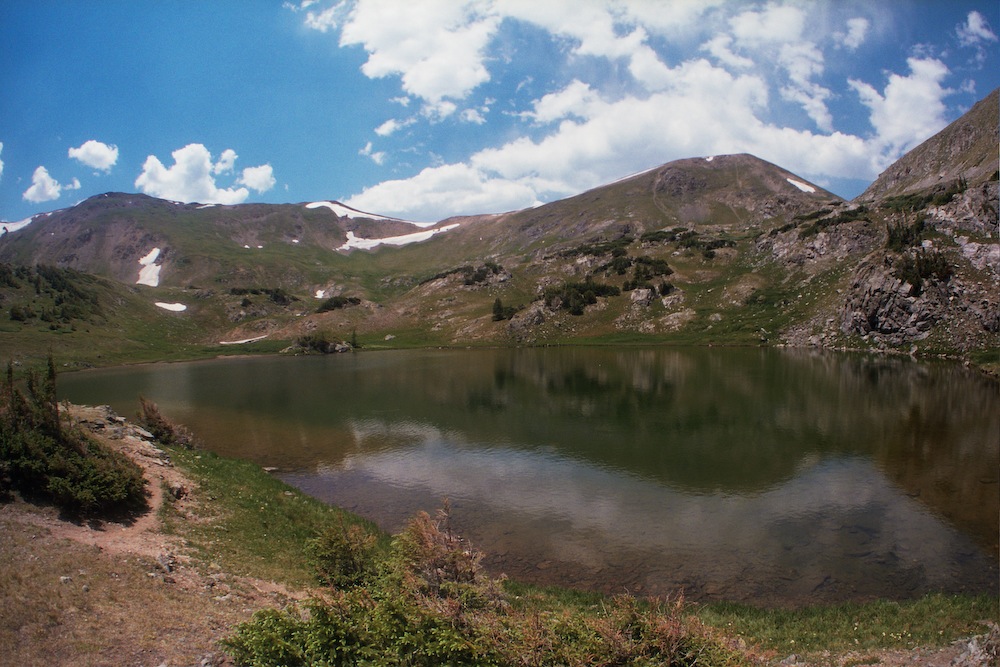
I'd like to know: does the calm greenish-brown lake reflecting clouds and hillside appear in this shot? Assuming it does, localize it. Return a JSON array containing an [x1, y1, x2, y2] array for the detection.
[[59, 348, 1000, 605]]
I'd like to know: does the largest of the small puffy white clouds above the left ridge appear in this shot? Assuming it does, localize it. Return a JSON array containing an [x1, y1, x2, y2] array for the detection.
[[135, 144, 274, 204]]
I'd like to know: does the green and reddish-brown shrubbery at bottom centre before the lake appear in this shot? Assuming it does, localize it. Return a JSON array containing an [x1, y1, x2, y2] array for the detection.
[[224, 505, 750, 667]]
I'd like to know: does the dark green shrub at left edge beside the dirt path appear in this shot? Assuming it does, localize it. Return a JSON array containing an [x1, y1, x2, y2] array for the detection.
[[0, 358, 146, 516]]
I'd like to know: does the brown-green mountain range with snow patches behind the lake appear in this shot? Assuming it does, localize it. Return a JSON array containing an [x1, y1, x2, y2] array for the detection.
[[0, 92, 1000, 363]]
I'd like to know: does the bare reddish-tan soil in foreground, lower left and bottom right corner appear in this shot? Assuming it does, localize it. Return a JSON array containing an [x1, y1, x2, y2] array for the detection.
[[0, 406, 1000, 667]]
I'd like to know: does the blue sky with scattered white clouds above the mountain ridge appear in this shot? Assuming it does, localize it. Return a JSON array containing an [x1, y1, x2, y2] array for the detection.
[[0, 0, 1000, 221]]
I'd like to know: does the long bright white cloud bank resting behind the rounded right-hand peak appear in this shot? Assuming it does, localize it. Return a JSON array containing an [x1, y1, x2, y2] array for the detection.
[[349, 60, 877, 219]]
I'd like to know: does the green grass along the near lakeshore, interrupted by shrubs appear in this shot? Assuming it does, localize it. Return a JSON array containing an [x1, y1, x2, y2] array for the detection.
[[165, 436, 1000, 655]]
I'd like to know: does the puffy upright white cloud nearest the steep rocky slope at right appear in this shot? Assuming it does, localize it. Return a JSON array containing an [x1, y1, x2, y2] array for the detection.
[[849, 58, 953, 161]]
